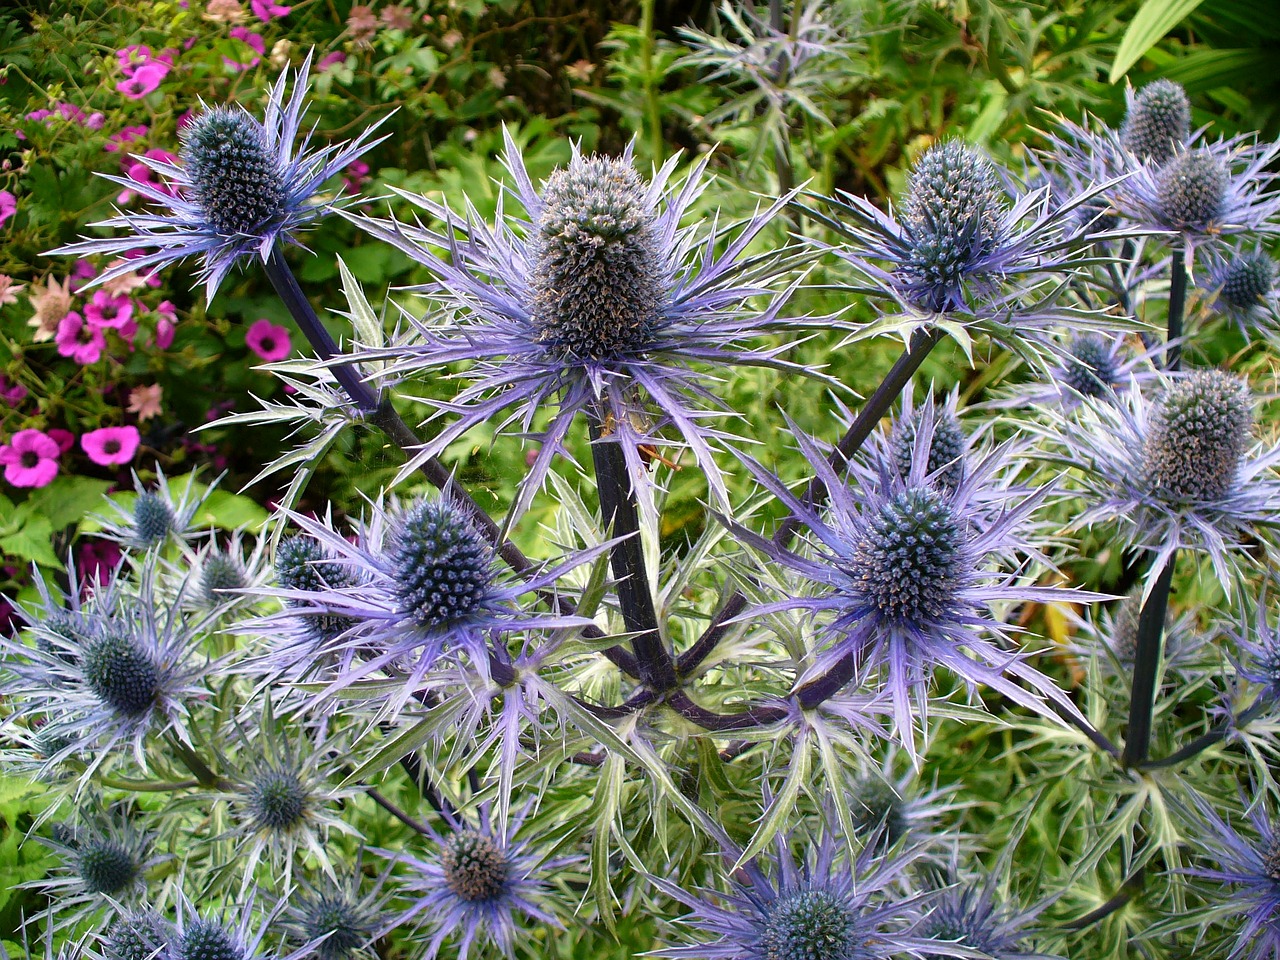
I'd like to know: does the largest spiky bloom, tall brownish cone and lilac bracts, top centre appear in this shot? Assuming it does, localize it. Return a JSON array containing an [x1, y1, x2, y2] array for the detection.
[[349, 133, 808, 515]]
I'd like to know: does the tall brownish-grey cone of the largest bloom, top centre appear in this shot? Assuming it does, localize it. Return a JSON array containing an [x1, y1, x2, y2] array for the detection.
[[530, 156, 663, 361]]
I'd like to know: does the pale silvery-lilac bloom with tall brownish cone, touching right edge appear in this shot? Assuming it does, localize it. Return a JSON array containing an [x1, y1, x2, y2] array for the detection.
[[1047, 370, 1280, 589]]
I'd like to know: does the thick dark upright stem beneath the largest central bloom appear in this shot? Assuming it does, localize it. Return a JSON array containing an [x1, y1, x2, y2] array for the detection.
[[591, 417, 678, 691]]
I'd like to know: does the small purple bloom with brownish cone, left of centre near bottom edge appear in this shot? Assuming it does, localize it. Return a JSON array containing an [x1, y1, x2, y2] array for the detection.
[[381, 805, 566, 960]]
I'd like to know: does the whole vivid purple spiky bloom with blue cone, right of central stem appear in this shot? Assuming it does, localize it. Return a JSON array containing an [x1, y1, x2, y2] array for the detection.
[[736, 416, 1100, 756]]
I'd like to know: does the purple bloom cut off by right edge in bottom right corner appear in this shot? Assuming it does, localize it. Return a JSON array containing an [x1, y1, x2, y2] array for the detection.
[[1181, 794, 1280, 960]]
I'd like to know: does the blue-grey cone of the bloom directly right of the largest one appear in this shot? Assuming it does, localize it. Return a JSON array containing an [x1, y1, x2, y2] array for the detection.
[[902, 141, 1007, 310]]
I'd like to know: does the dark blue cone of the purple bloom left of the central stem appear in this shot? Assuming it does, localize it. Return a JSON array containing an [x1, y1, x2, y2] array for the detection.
[[388, 500, 493, 630]]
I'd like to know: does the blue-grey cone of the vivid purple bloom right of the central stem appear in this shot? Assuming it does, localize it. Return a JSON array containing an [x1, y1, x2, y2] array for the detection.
[[850, 486, 961, 625]]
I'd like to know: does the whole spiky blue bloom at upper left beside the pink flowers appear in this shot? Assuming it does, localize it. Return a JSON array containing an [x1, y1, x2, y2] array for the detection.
[[51, 54, 385, 300]]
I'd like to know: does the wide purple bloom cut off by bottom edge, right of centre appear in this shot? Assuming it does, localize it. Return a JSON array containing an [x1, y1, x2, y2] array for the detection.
[[650, 831, 952, 960]]
